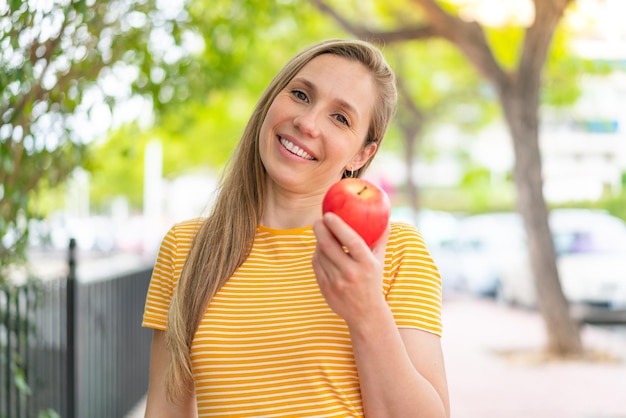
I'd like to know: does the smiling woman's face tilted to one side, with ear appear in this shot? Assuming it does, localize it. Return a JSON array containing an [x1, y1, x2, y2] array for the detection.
[[259, 54, 377, 194]]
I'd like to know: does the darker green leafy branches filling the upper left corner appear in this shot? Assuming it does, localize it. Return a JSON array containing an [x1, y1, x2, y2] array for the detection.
[[0, 0, 188, 274]]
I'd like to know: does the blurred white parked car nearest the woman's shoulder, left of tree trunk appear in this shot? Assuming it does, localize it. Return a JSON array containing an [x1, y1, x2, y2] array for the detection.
[[449, 212, 524, 297]]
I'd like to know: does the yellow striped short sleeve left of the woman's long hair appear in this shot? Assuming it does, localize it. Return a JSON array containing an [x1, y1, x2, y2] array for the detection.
[[141, 220, 199, 330]]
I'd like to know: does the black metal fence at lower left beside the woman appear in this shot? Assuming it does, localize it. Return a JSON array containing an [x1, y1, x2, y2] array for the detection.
[[0, 242, 152, 418]]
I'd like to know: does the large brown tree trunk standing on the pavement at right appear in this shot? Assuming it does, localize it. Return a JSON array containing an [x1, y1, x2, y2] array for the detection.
[[494, 0, 583, 356]]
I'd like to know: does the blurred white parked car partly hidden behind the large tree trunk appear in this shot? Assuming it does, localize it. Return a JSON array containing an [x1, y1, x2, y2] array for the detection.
[[498, 209, 626, 316]]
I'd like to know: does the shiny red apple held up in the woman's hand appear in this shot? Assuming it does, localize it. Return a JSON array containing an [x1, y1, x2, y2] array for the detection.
[[322, 178, 391, 247]]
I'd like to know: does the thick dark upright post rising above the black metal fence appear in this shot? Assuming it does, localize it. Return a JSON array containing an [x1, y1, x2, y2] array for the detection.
[[66, 238, 76, 418]]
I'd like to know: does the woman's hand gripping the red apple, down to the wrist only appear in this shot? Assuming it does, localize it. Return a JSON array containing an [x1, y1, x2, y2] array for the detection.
[[313, 212, 389, 327]]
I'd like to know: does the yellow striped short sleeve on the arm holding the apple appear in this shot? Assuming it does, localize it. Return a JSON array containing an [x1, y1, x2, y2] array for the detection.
[[383, 222, 442, 336]]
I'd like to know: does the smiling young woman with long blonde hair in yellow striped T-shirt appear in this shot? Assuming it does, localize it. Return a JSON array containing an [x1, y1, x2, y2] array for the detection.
[[143, 40, 449, 418]]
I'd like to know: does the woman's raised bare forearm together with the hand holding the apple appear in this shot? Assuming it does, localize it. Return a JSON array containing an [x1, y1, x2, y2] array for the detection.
[[313, 213, 450, 418]]
